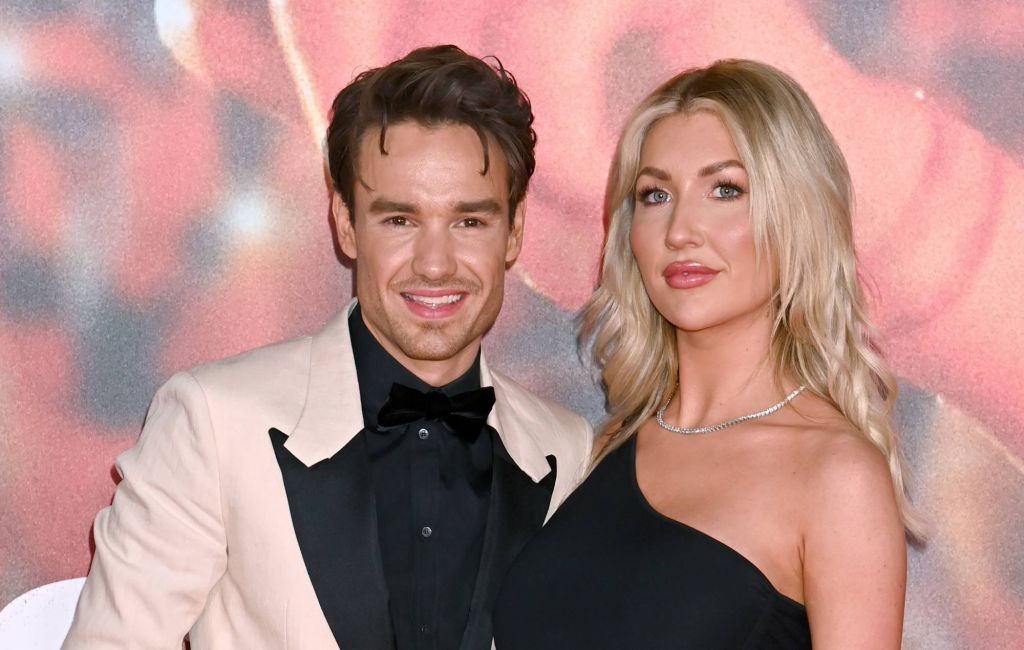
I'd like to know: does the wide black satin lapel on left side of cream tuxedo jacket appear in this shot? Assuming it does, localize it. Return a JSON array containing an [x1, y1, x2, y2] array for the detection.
[[269, 429, 394, 650]]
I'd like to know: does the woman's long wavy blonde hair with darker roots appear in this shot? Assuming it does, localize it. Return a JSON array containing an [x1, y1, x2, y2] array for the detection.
[[581, 59, 924, 537]]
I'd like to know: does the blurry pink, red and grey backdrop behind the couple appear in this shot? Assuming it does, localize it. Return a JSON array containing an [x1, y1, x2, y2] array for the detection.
[[0, 0, 1024, 649]]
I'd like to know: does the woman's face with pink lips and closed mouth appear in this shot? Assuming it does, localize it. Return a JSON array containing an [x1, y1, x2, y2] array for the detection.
[[630, 112, 771, 332]]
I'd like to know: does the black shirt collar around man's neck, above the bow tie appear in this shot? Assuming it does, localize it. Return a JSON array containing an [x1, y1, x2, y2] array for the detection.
[[348, 305, 480, 429]]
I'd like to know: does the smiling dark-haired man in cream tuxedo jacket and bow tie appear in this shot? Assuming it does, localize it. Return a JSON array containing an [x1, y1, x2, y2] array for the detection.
[[65, 46, 591, 650]]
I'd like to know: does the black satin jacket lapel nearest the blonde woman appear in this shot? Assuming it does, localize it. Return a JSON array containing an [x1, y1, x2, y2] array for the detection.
[[460, 433, 557, 650]]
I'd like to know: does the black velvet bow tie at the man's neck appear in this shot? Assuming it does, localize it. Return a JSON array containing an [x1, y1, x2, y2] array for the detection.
[[377, 384, 495, 440]]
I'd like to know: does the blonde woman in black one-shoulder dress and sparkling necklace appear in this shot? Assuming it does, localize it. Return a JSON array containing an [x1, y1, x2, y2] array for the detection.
[[495, 60, 921, 650]]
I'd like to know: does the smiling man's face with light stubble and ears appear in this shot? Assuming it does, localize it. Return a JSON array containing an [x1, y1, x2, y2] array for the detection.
[[334, 122, 523, 386]]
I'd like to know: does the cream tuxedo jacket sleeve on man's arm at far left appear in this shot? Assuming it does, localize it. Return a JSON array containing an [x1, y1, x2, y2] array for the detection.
[[62, 373, 227, 650]]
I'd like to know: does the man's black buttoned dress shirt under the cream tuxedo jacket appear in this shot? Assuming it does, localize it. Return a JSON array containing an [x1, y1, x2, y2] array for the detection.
[[348, 306, 495, 650]]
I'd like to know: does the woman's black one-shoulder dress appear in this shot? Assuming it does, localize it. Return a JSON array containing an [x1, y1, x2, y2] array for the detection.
[[494, 437, 811, 650]]
